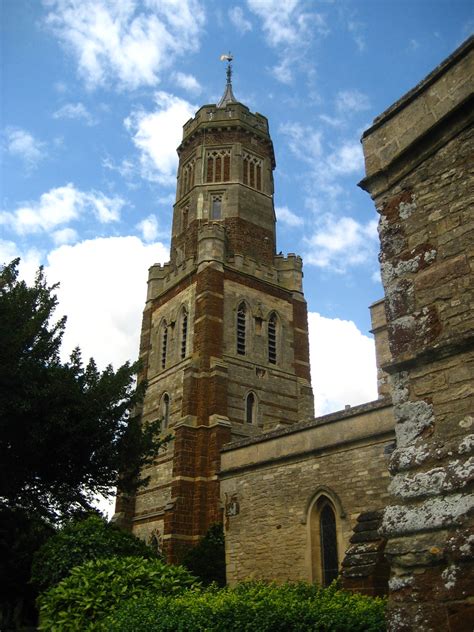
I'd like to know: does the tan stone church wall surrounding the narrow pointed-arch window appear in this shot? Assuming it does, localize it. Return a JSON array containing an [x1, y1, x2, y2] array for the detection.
[[220, 401, 394, 583]]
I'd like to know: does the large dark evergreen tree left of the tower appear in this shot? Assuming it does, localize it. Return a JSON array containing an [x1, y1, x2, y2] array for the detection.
[[0, 259, 166, 521]]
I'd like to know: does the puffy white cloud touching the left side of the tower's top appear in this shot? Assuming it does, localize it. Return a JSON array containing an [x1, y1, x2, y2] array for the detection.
[[124, 92, 197, 186]]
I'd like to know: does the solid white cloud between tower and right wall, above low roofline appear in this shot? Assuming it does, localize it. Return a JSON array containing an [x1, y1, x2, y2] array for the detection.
[[308, 312, 377, 416]]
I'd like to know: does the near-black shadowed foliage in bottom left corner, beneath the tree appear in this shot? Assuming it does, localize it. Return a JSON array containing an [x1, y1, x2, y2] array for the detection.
[[0, 508, 54, 630]]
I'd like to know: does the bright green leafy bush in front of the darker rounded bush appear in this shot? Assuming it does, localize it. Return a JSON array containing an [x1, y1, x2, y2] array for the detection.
[[38, 557, 199, 632]]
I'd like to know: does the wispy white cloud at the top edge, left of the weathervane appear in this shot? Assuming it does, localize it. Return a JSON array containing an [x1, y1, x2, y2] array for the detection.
[[45, 0, 205, 89]]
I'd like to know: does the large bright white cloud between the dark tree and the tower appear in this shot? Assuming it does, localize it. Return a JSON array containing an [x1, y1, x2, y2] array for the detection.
[[45, 237, 168, 368]]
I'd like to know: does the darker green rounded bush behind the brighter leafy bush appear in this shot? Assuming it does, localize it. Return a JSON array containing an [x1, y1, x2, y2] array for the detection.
[[31, 515, 156, 592]]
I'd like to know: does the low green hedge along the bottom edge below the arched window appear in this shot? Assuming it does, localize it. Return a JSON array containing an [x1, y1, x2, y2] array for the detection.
[[102, 582, 385, 632]]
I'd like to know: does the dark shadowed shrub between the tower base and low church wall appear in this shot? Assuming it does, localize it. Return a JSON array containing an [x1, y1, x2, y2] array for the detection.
[[183, 524, 225, 586]]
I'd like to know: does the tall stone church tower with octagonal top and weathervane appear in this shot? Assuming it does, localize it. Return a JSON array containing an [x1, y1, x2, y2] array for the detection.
[[117, 56, 313, 562]]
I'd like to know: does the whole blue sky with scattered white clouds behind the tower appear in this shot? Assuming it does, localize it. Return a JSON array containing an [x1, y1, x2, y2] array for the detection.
[[0, 0, 474, 413]]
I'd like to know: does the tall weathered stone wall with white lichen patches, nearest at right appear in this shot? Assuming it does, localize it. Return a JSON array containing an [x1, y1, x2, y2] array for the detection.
[[361, 38, 474, 632]]
